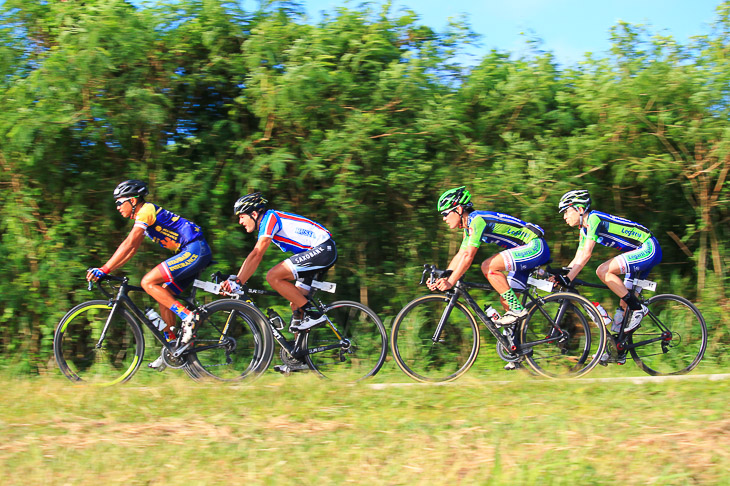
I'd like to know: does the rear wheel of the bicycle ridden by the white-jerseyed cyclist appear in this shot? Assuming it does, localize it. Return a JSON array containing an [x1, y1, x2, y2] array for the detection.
[[304, 300, 388, 382]]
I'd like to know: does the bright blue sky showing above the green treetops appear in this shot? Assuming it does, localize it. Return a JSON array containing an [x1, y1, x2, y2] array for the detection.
[[242, 0, 723, 65]]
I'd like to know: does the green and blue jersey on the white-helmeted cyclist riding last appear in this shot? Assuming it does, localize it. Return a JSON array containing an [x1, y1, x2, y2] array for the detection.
[[578, 211, 652, 250]]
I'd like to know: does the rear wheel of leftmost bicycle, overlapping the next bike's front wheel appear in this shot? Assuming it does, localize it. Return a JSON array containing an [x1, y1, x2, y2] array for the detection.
[[185, 299, 274, 382]]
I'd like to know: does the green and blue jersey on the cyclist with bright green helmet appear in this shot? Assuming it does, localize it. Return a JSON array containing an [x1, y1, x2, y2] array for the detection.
[[460, 211, 544, 250]]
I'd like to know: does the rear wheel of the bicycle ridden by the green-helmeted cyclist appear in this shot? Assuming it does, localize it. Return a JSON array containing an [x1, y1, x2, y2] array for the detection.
[[520, 292, 606, 378]]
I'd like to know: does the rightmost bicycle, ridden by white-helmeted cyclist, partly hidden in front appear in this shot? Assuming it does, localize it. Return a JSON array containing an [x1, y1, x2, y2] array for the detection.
[[569, 278, 707, 376]]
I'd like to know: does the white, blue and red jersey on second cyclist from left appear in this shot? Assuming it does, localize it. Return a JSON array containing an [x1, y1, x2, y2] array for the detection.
[[258, 209, 332, 253]]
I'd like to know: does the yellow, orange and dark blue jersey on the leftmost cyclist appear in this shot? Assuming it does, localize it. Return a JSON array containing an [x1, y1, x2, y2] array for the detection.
[[134, 203, 203, 251]]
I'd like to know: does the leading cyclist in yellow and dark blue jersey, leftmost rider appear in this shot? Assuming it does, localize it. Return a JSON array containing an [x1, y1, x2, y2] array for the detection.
[[86, 179, 212, 370]]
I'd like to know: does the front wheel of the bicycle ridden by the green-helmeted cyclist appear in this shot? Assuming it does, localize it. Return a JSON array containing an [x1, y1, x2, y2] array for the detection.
[[391, 295, 479, 382]]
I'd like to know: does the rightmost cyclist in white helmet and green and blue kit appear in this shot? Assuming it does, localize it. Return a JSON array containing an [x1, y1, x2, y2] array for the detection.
[[557, 190, 662, 332]]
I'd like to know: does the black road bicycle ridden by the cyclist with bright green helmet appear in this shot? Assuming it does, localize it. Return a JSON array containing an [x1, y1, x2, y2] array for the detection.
[[391, 265, 606, 382]]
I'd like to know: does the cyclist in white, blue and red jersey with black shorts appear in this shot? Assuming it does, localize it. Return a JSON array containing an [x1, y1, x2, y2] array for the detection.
[[221, 192, 337, 331]]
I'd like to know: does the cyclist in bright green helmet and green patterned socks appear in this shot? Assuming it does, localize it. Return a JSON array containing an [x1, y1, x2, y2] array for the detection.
[[428, 186, 550, 326]]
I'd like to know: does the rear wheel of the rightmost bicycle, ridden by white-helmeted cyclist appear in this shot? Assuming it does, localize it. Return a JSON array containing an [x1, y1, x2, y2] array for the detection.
[[629, 294, 707, 375]]
